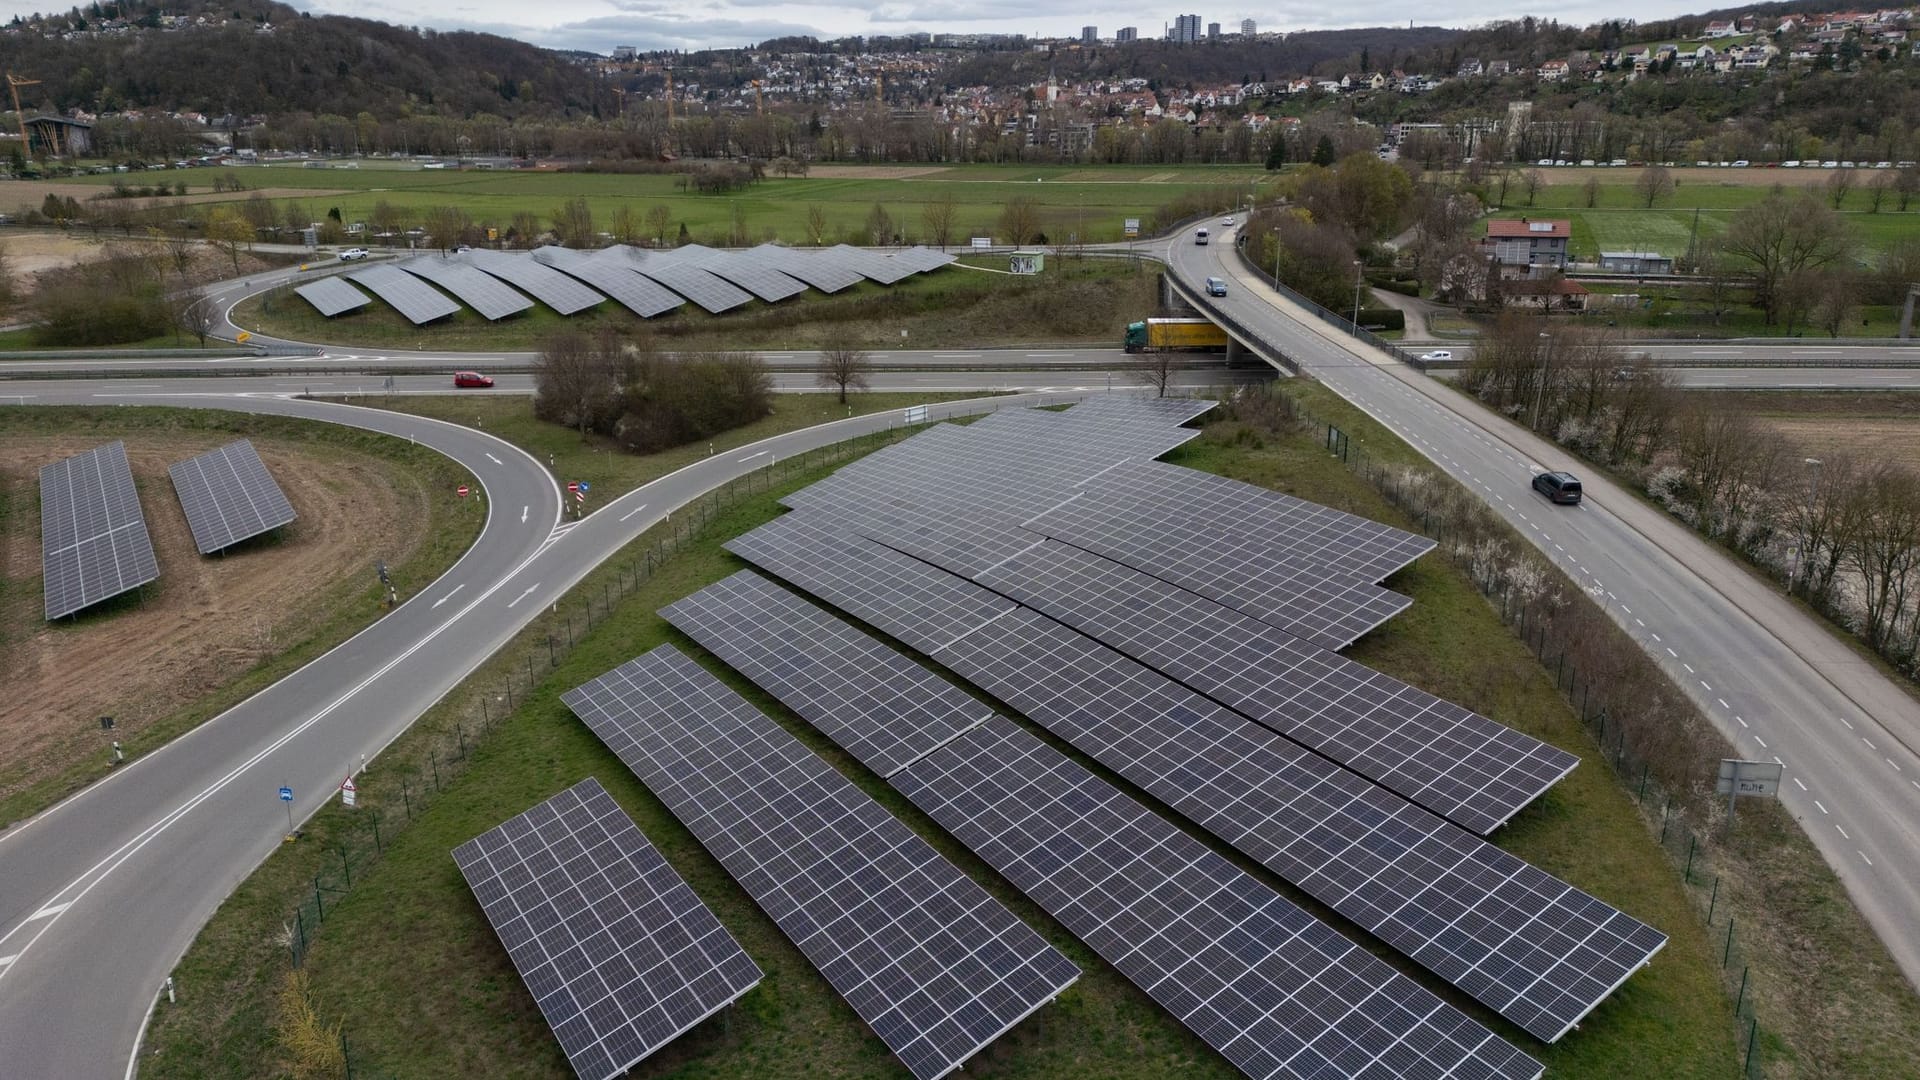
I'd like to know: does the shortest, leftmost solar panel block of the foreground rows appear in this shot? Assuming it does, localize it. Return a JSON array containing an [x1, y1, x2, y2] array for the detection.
[[453, 778, 760, 1080]]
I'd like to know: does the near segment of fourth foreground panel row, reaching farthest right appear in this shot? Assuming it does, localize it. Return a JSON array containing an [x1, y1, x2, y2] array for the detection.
[[933, 609, 1667, 1042]]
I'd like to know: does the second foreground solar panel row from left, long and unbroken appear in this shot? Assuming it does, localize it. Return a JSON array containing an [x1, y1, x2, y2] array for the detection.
[[563, 646, 1079, 1080]]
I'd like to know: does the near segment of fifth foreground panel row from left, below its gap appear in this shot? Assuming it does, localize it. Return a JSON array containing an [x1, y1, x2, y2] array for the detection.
[[979, 540, 1580, 834]]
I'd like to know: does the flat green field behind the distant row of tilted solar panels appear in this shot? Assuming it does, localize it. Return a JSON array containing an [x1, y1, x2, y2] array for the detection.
[[52, 165, 1265, 244]]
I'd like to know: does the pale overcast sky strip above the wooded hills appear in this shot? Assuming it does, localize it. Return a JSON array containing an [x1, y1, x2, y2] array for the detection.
[[11, 0, 1716, 54]]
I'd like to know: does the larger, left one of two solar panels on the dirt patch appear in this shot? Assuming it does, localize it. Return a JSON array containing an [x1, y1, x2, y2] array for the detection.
[[40, 442, 159, 619]]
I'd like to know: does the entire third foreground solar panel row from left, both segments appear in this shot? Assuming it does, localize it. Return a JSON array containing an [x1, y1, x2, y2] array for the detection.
[[664, 571, 1540, 1080]]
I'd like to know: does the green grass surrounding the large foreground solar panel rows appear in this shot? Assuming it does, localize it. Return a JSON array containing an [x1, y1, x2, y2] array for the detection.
[[142, 395, 1738, 1080]]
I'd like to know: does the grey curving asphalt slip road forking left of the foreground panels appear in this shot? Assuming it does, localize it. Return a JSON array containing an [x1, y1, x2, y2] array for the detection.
[[0, 380, 1077, 1080]]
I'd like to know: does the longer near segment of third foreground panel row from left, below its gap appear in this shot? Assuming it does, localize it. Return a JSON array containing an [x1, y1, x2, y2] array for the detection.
[[893, 717, 1542, 1080]]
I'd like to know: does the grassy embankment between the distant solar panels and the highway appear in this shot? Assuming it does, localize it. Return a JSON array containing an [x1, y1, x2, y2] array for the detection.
[[232, 258, 1156, 352]]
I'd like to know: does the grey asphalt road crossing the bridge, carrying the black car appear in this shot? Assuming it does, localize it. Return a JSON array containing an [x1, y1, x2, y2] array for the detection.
[[1165, 226, 1920, 984]]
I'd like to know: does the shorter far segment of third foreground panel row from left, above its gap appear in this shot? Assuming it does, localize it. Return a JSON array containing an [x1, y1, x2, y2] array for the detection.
[[660, 571, 993, 776]]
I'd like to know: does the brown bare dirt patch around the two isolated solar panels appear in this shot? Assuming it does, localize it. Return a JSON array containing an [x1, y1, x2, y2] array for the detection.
[[0, 434, 426, 796]]
